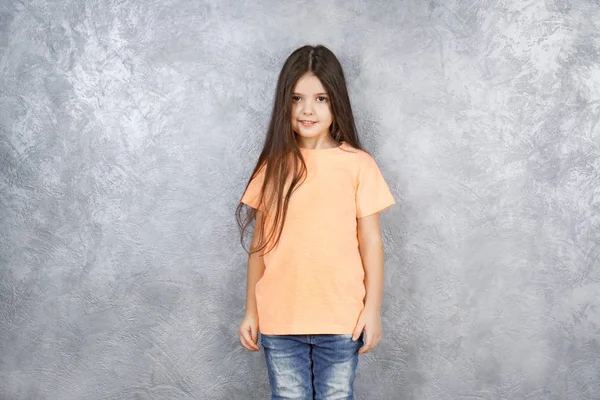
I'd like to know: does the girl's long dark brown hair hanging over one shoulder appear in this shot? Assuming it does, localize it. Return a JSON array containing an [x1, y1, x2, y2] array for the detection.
[[235, 45, 362, 254]]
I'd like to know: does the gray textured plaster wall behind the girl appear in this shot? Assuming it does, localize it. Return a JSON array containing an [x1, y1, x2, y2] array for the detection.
[[0, 0, 600, 400]]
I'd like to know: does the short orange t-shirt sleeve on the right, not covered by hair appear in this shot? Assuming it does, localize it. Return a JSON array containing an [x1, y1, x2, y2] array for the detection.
[[356, 152, 396, 218]]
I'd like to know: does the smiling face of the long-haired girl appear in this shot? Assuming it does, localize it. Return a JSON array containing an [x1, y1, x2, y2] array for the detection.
[[292, 74, 333, 140]]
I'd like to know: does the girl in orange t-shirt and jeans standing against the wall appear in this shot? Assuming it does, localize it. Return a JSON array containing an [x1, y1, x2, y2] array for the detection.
[[236, 45, 395, 399]]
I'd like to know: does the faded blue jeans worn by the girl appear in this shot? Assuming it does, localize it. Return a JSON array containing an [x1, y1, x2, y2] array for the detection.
[[261, 333, 364, 400]]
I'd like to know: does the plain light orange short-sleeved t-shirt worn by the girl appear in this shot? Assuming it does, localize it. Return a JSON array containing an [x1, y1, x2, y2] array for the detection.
[[242, 142, 395, 335]]
